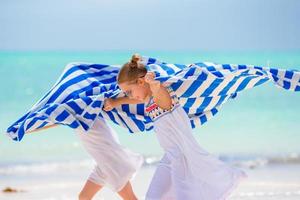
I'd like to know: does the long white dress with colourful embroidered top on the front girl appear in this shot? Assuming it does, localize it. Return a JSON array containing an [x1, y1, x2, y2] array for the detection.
[[146, 88, 246, 200]]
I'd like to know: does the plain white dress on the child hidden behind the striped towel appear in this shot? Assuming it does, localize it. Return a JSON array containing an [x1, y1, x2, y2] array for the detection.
[[76, 118, 143, 192]]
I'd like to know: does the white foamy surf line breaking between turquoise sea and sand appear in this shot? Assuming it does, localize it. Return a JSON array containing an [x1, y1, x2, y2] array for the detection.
[[0, 153, 300, 175]]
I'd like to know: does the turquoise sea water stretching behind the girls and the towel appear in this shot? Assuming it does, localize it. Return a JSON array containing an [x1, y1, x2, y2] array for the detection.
[[0, 51, 300, 171]]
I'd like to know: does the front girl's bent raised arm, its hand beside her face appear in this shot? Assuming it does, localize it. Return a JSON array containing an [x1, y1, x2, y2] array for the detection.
[[145, 72, 172, 110]]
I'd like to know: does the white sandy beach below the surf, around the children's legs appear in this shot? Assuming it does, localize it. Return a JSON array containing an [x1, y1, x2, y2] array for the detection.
[[0, 164, 300, 200]]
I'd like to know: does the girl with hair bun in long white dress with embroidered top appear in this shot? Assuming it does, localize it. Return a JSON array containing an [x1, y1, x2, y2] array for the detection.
[[107, 55, 246, 200]]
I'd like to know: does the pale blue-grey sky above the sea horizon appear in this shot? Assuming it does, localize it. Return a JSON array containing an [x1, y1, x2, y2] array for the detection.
[[0, 0, 300, 51]]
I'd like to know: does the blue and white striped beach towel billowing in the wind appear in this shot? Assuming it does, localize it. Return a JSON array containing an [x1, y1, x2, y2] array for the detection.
[[7, 57, 300, 141]]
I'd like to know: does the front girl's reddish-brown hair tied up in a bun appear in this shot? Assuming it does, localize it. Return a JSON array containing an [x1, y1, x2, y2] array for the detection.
[[117, 54, 147, 84]]
